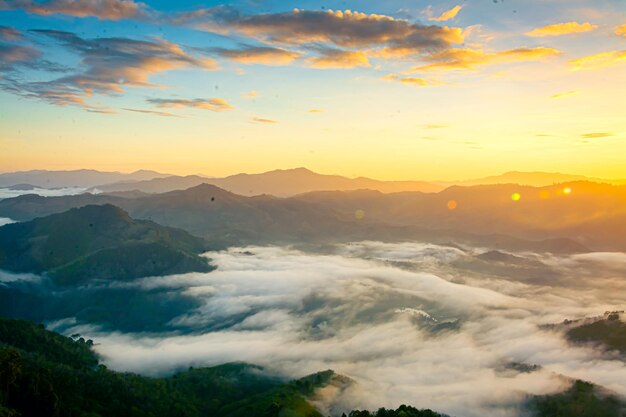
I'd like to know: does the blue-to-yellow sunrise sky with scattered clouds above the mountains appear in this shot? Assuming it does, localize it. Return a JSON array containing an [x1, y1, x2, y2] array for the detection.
[[0, 0, 626, 180]]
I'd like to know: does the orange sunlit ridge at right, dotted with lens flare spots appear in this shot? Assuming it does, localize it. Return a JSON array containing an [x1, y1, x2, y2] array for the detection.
[[297, 181, 626, 250]]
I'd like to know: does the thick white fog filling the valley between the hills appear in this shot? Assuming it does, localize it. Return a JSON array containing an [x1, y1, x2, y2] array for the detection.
[[50, 242, 626, 417]]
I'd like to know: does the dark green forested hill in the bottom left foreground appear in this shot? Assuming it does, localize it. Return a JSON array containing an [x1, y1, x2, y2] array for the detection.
[[0, 318, 335, 417]]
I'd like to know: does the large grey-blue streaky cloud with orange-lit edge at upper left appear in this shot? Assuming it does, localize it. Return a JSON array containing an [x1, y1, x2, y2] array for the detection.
[[0, 30, 217, 110]]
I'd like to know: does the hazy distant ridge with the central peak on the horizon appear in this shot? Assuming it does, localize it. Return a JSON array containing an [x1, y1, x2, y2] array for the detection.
[[96, 168, 443, 197]]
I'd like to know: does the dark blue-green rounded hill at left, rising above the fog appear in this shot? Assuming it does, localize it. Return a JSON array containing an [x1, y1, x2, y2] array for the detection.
[[0, 205, 212, 285]]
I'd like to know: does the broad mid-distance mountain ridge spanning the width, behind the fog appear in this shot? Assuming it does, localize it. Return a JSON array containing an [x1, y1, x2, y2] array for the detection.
[[0, 183, 604, 252]]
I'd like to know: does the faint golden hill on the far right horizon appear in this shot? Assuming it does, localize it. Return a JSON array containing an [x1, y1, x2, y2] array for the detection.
[[437, 171, 626, 187]]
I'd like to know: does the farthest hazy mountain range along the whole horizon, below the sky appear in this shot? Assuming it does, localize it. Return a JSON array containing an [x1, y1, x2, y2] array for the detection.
[[0, 168, 626, 197]]
